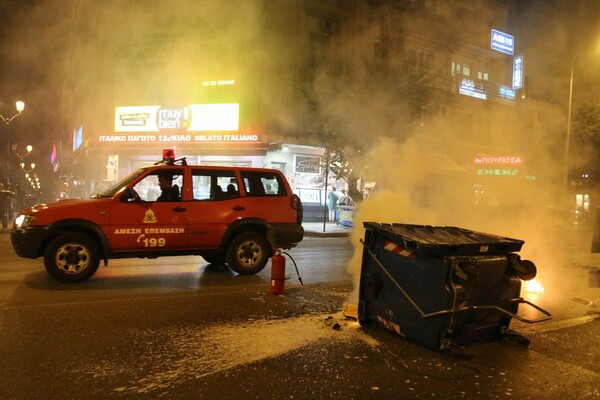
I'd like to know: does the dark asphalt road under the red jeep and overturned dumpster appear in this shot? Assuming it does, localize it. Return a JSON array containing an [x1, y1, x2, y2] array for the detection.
[[0, 230, 600, 400]]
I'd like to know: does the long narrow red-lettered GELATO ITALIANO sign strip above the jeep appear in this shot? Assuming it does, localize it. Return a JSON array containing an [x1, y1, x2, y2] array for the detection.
[[98, 132, 260, 143]]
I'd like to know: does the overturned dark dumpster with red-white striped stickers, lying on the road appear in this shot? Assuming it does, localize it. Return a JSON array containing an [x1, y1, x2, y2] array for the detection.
[[358, 222, 551, 351]]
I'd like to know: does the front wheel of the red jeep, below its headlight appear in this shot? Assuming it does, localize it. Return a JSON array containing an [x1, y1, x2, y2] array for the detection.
[[44, 233, 100, 283]]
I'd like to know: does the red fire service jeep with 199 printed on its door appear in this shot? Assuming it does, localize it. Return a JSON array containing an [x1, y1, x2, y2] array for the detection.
[[11, 152, 304, 282]]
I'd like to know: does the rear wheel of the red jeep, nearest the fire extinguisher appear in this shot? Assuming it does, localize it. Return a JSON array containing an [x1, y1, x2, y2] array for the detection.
[[226, 231, 270, 275]]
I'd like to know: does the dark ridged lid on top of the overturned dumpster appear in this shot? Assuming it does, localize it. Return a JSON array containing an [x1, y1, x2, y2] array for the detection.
[[364, 222, 525, 255]]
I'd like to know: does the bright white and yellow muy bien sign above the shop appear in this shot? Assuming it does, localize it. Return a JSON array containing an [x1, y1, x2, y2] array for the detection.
[[115, 103, 240, 133]]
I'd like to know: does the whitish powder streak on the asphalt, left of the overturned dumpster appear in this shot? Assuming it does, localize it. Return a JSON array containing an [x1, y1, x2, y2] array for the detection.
[[83, 312, 378, 394]]
